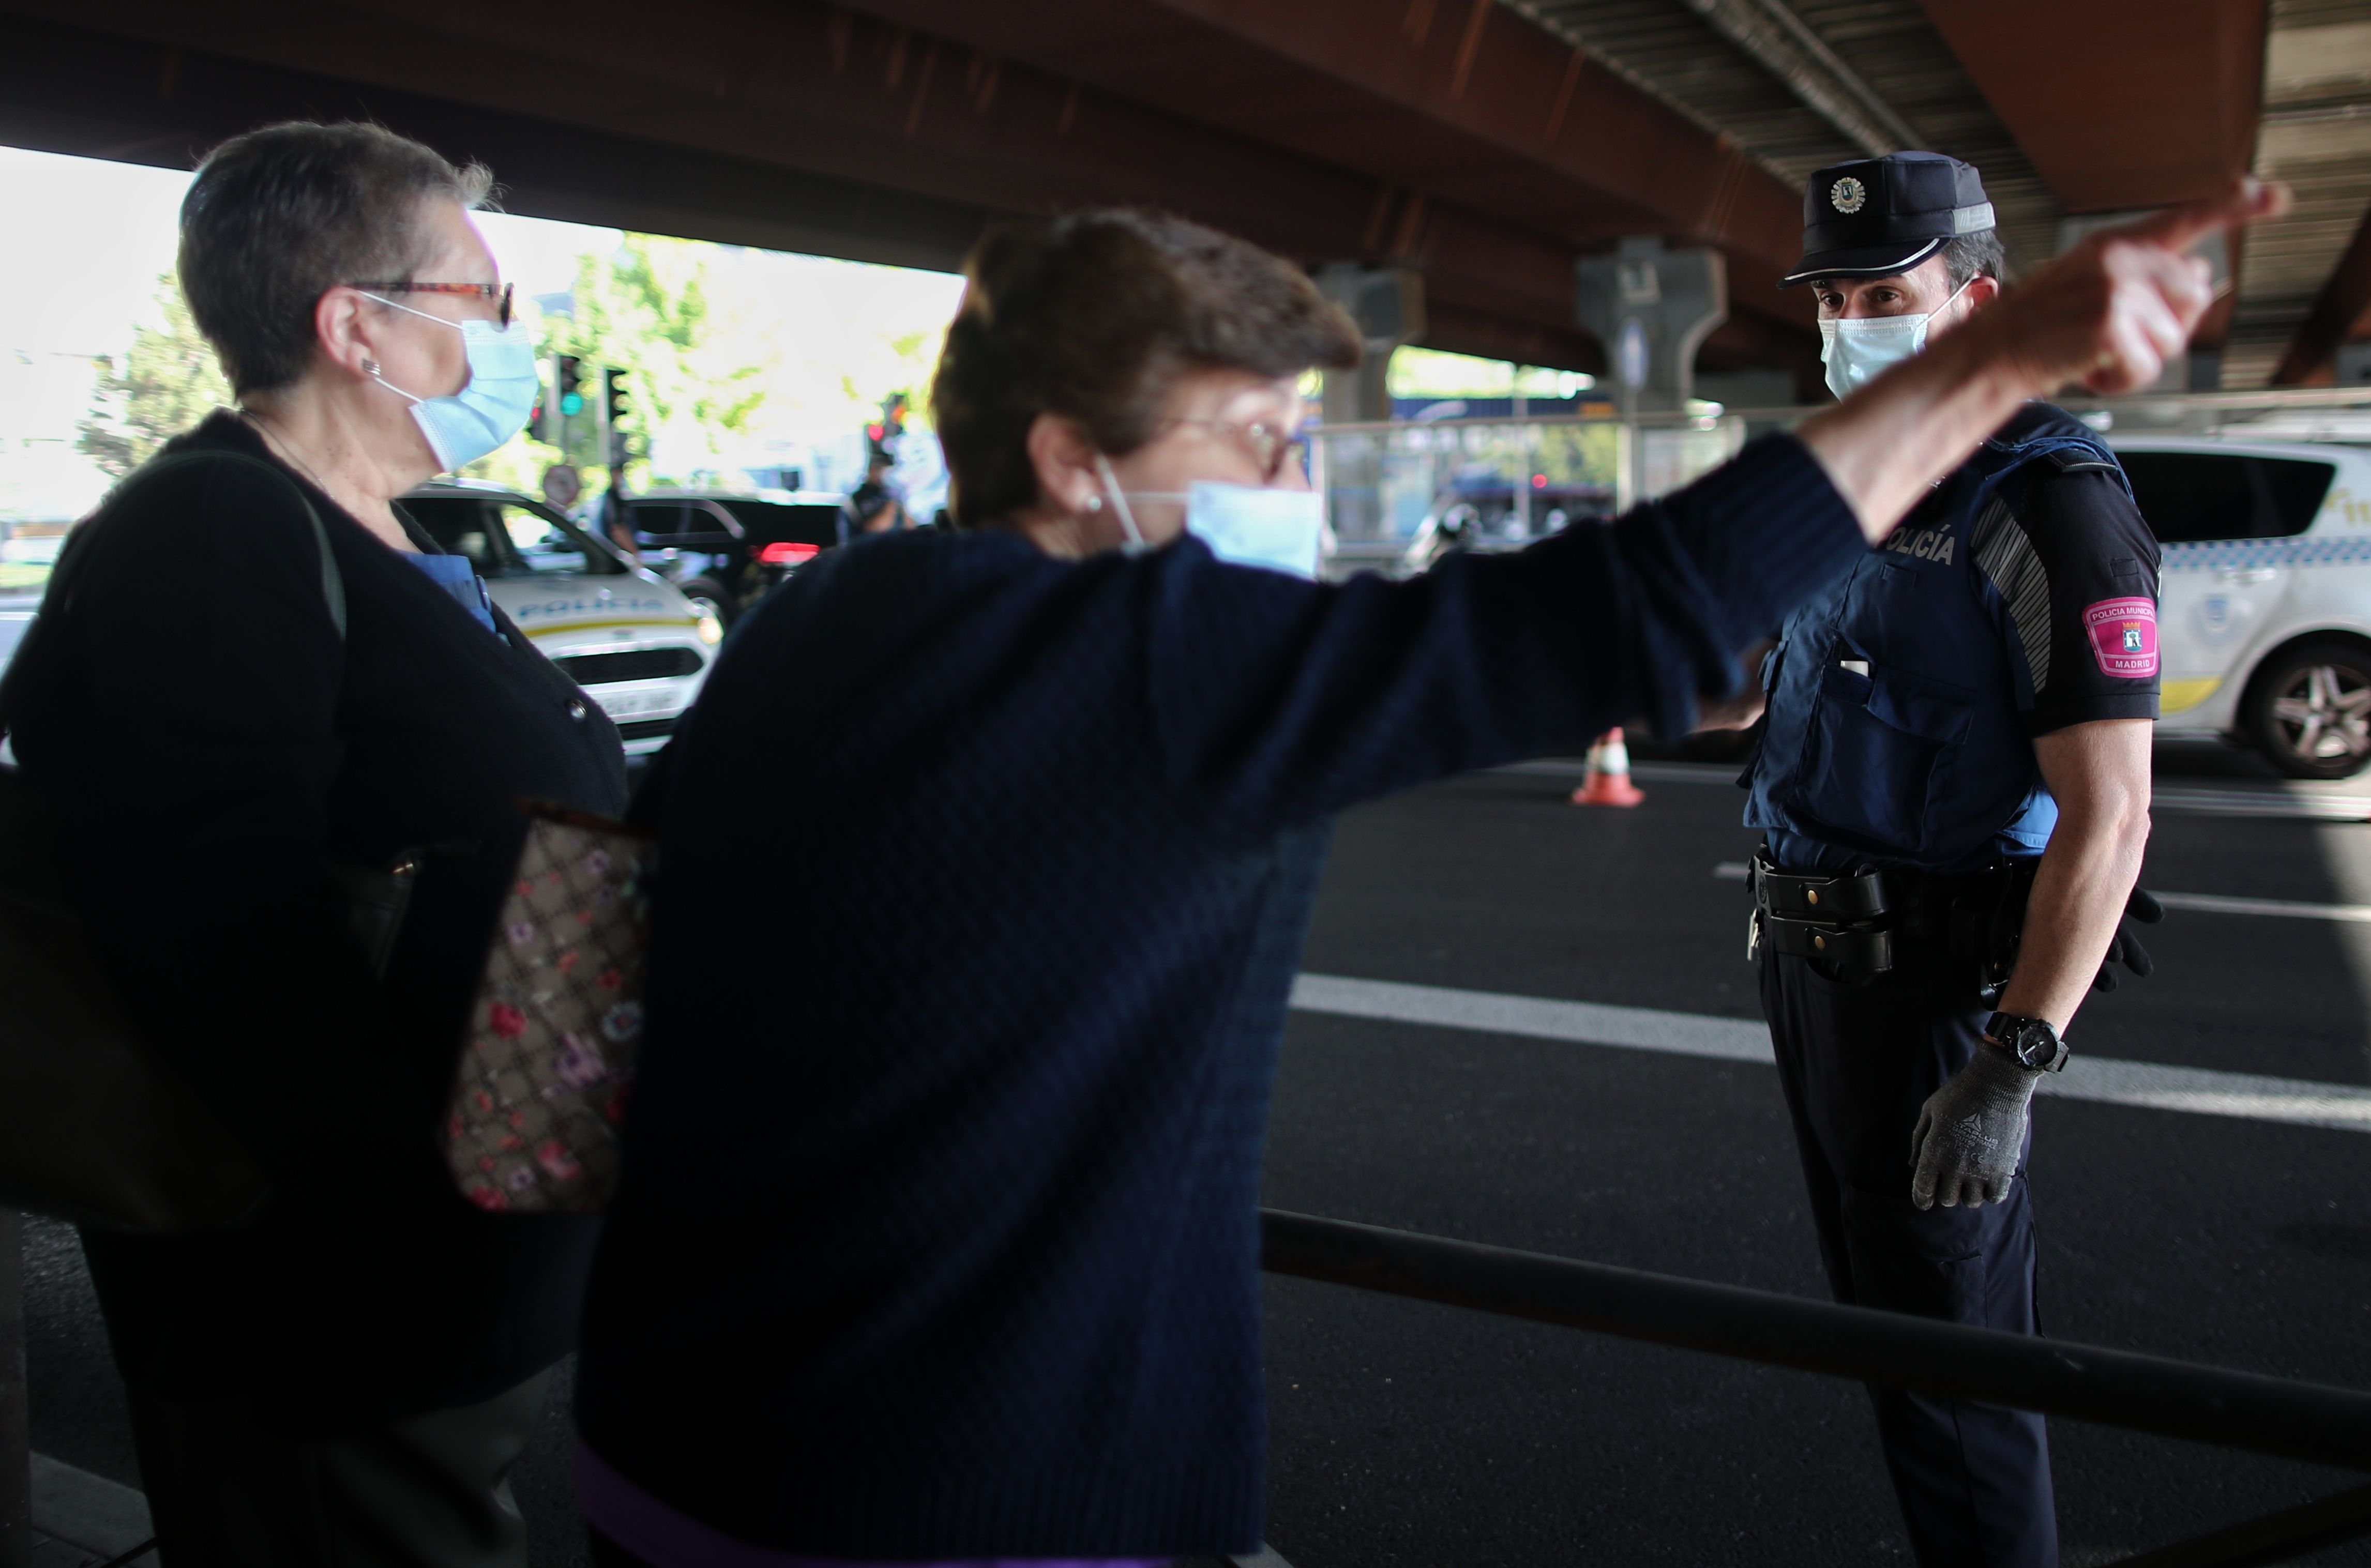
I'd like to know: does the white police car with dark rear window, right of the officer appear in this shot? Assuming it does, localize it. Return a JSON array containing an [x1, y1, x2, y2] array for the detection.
[[2110, 433, 2371, 779]]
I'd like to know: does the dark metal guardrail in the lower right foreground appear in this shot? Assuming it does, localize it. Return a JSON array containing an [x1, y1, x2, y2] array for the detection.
[[1259, 1208, 2371, 1568]]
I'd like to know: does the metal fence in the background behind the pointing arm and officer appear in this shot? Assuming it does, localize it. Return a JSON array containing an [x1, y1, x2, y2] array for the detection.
[[1311, 386, 2371, 573]]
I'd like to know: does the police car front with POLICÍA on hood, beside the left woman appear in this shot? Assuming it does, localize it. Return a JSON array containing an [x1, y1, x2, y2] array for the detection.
[[401, 478, 726, 756]]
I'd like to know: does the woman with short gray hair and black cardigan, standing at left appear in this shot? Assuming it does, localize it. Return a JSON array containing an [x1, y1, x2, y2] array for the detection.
[[9, 126, 626, 1568]]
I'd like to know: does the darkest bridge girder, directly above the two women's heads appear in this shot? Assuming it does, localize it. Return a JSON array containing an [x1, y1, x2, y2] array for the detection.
[[0, 0, 1807, 370]]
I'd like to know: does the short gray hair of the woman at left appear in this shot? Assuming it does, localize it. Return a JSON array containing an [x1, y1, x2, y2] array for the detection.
[[180, 121, 493, 393]]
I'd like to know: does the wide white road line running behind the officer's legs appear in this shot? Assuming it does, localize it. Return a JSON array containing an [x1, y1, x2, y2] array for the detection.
[[1292, 973, 2371, 1132]]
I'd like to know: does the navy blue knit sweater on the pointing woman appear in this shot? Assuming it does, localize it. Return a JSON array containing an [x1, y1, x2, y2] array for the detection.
[[579, 438, 1864, 1559]]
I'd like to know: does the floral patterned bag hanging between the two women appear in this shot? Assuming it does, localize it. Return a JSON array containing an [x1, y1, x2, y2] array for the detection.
[[446, 803, 659, 1213]]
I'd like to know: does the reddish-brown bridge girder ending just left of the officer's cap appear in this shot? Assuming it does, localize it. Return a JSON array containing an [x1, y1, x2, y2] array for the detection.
[[825, 0, 1811, 317]]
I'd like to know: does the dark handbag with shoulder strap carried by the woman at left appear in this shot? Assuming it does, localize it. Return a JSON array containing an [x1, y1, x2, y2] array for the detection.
[[0, 452, 417, 1237]]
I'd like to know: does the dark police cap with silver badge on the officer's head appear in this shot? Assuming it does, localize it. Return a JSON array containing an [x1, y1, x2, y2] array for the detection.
[[1778, 151, 1991, 289]]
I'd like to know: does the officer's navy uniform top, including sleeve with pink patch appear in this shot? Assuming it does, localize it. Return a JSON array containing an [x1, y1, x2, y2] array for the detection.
[[1745, 403, 2157, 874]]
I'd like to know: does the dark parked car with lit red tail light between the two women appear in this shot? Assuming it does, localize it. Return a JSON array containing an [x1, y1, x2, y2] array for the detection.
[[626, 490, 842, 626]]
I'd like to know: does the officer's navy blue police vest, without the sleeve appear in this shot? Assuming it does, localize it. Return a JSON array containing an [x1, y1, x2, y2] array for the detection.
[[1745, 403, 2132, 872]]
